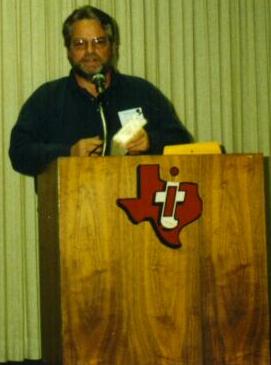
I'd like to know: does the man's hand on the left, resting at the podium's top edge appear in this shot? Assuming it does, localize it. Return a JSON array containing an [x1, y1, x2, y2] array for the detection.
[[71, 136, 103, 157]]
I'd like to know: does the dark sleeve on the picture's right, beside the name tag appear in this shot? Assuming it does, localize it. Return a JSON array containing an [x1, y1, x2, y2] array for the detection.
[[146, 83, 193, 154]]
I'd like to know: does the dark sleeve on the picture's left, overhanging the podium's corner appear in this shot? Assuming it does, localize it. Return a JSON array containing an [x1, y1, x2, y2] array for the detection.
[[9, 84, 70, 176]]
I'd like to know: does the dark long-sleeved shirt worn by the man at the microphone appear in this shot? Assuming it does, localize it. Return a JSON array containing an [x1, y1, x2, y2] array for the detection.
[[9, 72, 192, 176]]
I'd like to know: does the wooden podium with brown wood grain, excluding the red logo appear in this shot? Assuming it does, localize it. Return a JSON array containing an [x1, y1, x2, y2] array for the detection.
[[38, 154, 270, 365]]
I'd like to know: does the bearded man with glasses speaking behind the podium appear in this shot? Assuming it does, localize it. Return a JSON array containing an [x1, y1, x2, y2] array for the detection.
[[9, 6, 191, 176]]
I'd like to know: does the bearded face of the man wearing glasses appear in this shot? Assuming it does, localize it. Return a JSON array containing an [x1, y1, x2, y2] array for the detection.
[[68, 19, 112, 79]]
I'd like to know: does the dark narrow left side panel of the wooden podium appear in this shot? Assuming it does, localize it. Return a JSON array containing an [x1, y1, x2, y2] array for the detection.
[[37, 162, 63, 364]]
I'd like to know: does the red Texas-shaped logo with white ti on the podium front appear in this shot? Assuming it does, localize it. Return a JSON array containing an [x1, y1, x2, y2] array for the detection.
[[117, 165, 202, 248]]
